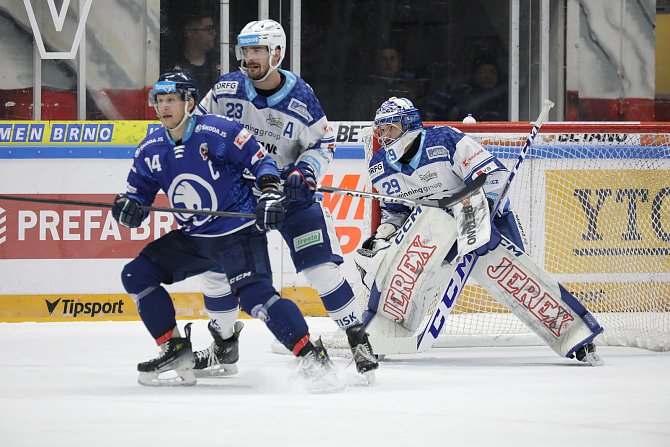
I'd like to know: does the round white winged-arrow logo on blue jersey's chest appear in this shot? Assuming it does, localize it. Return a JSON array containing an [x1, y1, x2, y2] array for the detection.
[[167, 174, 219, 227]]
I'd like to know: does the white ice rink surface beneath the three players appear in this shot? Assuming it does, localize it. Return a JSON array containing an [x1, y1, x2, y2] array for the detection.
[[0, 318, 670, 447]]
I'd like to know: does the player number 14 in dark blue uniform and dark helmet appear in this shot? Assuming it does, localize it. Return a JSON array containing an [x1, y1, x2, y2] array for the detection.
[[112, 72, 342, 386]]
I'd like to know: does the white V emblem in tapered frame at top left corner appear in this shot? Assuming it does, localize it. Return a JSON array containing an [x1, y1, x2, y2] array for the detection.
[[23, 0, 93, 59]]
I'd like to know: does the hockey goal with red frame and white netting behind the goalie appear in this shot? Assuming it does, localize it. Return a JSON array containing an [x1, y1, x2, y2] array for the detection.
[[329, 123, 670, 350]]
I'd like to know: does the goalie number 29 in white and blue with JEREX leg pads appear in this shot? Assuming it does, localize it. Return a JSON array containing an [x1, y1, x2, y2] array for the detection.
[[355, 97, 602, 365]]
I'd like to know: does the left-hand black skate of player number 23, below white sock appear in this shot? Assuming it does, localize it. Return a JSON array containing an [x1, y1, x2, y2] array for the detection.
[[193, 321, 244, 377]]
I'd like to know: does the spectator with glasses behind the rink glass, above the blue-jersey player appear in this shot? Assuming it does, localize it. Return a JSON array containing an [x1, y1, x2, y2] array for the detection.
[[165, 10, 220, 98]]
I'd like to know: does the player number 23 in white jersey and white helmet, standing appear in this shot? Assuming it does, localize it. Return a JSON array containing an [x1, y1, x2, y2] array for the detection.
[[196, 20, 378, 380]]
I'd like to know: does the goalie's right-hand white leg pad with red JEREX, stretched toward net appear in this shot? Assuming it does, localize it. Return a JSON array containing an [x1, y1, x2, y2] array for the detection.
[[472, 237, 602, 358]]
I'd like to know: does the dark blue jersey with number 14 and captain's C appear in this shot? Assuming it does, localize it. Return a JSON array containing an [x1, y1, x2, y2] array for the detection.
[[127, 115, 279, 236]]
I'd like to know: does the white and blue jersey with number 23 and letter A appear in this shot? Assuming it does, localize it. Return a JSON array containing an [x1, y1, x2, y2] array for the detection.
[[198, 69, 335, 180]]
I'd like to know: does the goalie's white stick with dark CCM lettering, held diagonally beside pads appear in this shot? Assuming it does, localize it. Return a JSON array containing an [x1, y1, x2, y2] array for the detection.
[[416, 99, 554, 352]]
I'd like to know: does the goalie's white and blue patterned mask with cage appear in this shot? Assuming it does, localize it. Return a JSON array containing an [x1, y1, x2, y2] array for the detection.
[[373, 96, 423, 163]]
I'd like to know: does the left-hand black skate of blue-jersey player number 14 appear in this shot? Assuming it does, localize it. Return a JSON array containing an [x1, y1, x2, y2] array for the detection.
[[137, 323, 196, 386]]
